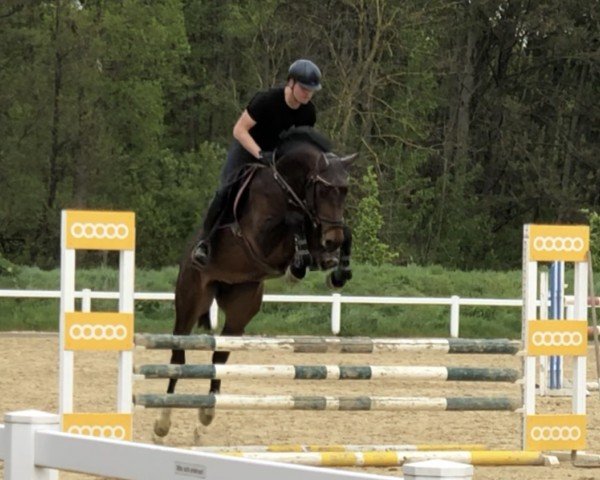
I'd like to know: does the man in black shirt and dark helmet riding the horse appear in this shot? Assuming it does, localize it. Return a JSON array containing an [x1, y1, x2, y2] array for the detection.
[[192, 59, 321, 266]]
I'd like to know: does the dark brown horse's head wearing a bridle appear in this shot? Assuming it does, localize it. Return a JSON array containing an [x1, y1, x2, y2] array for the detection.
[[305, 152, 356, 252]]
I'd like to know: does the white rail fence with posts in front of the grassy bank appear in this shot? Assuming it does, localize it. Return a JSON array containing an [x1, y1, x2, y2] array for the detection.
[[0, 289, 523, 338]]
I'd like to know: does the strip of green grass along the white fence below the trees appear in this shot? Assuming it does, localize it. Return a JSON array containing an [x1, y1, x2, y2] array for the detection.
[[0, 265, 536, 338]]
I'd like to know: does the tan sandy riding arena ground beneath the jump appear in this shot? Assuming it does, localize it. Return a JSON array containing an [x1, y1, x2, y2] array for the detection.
[[0, 334, 600, 480]]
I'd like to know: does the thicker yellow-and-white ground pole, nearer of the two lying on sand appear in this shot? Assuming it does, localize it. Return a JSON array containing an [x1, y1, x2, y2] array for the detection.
[[218, 450, 545, 467]]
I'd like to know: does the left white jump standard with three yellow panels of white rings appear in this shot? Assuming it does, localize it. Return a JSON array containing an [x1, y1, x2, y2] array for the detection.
[[59, 210, 135, 440]]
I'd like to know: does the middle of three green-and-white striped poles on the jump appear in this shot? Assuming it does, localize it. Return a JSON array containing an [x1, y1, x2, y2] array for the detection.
[[135, 364, 520, 383]]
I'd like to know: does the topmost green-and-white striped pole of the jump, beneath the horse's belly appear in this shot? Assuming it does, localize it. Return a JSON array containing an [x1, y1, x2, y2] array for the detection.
[[135, 333, 520, 355]]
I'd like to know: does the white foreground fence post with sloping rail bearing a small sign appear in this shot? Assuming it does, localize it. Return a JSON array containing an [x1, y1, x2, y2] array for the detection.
[[0, 410, 398, 480]]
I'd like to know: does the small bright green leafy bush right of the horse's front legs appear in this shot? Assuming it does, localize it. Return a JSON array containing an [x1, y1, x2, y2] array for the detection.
[[352, 167, 398, 265]]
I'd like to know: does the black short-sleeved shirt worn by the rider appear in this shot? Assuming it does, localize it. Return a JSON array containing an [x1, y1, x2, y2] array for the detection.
[[246, 87, 317, 150]]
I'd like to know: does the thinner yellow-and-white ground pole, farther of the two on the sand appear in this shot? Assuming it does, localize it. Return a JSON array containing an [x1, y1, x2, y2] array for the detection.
[[192, 443, 487, 453]]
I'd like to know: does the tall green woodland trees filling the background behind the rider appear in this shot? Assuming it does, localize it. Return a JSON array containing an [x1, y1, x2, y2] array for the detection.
[[0, 0, 600, 270]]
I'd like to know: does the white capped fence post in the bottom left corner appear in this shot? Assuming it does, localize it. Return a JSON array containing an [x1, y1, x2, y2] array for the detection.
[[4, 410, 60, 480]]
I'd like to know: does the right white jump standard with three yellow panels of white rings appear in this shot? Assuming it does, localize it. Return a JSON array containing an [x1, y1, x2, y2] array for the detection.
[[522, 225, 590, 451]]
